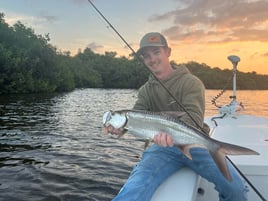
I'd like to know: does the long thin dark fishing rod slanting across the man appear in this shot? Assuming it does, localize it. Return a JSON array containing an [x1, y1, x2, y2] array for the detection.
[[88, 0, 267, 201]]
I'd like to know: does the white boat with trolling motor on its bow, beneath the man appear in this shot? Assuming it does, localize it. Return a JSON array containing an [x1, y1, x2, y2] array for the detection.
[[152, 56, 268, 201]]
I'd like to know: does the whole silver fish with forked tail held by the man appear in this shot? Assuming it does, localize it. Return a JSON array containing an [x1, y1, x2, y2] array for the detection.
[[102, 110, 259, 181]]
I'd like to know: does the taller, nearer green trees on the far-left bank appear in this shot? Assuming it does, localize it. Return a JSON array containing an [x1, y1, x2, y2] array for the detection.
[[0, 13, 101, 94]]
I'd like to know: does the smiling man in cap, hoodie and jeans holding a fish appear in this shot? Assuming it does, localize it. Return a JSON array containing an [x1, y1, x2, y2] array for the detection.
[[108, 32, 247, 201]]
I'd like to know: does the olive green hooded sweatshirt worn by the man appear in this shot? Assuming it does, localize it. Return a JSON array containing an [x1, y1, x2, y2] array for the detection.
[[133, 65, 207, 133]]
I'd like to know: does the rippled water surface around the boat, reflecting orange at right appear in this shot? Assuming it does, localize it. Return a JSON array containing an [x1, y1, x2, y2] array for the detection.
[[0, 89, 268, 201]]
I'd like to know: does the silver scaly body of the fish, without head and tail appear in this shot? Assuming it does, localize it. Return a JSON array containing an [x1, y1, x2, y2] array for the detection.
[[125, 111, 208, 146]]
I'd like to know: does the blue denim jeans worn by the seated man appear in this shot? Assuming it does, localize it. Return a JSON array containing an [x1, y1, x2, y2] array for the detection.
[[113, 145, 248, 201]]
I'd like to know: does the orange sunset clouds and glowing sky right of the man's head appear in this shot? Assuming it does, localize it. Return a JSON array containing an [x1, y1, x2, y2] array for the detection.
[[149, 0, 268, 74]]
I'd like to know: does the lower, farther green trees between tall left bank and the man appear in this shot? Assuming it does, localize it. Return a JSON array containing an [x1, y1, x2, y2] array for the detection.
[[74, 48, 148, 88]]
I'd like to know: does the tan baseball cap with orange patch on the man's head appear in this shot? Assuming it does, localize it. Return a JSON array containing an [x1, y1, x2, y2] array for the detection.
[[137, 32, 168, 55]]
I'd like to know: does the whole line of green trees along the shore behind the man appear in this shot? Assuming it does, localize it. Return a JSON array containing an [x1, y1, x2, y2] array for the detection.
[[0, 13, 268, 94]]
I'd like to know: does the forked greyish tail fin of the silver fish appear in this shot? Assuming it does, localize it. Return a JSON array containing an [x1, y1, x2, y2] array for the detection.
[[210, 143, 259, 181]]
